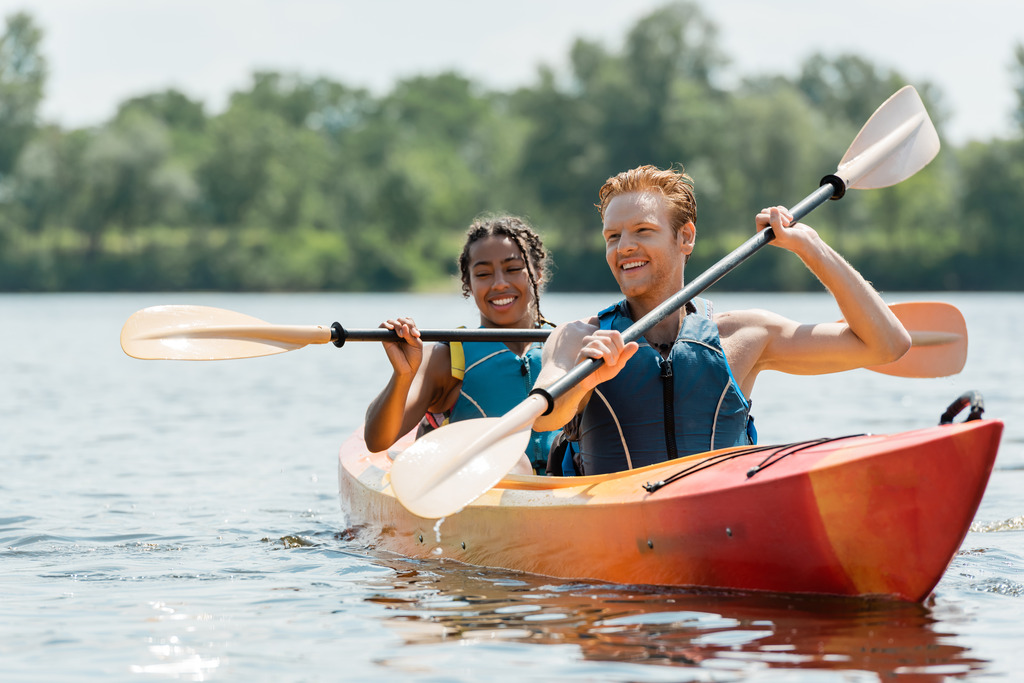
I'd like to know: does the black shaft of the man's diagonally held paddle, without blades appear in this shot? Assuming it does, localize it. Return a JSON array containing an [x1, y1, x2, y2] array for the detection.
[[530, 175, 846, 415]]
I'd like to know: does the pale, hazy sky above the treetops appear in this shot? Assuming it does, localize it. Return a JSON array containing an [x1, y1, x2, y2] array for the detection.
[[6, 0, 1024, 144]]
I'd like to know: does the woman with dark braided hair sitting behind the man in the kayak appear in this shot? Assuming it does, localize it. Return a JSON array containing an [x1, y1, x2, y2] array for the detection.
[[364, 216, 557, 473]]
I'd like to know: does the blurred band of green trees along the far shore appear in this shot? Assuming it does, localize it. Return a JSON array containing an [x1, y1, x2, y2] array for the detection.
[[0, 2, 1024, 291]]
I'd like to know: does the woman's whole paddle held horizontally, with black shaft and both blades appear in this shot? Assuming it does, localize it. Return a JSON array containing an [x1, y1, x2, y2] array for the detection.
[[121, 302, 967, 377]]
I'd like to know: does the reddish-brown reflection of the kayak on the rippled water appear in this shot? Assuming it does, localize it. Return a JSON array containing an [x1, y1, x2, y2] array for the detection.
[[356, 557, 987, 682]]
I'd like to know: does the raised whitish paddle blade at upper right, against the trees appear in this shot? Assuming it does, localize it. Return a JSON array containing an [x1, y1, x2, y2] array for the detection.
[[836, 85, 940, 189]]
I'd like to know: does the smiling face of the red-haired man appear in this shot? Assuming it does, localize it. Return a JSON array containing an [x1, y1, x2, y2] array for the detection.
[[603, 190, 695, 305]]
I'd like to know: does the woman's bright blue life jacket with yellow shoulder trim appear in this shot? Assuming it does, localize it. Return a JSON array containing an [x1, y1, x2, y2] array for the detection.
[[432, 341, 560, 473]]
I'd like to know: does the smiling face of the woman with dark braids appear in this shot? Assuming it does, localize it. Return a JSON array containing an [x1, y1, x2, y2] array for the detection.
[[469, 236, 536, 328]]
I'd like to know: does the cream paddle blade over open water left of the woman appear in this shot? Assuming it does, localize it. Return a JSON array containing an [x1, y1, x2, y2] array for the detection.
[[121, 305, 331, 360]]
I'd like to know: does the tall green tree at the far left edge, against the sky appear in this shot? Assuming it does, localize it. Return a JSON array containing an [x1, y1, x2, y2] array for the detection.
[[0, 12, 46, 177]]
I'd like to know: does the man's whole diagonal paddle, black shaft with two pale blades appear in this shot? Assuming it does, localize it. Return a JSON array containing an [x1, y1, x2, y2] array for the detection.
[[391, 86, 939, 518]]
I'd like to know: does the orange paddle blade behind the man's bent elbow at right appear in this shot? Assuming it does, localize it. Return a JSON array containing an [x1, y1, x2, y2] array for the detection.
[[868, 301, 967, 377]]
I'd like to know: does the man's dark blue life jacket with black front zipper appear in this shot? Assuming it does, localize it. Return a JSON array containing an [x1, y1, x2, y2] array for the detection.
[[580, 299, 757, 474]]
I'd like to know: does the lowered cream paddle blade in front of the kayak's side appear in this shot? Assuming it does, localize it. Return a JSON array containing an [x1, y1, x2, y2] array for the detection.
[[391, 395, 547, 519]]
